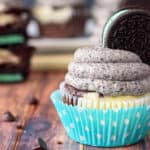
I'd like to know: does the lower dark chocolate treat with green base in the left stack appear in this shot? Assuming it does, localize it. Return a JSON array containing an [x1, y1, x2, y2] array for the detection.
[[0, 45, 34, 83]]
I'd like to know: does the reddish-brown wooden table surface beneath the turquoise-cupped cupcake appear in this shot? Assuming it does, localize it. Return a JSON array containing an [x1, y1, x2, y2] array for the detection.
[[0, 72, 150, 150]]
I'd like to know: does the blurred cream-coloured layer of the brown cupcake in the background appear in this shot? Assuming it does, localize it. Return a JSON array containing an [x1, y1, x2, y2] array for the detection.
[[33, 6, 73, 24]]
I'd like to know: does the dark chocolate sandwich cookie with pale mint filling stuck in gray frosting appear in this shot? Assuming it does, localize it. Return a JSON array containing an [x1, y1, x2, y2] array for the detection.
[[102, 8, 150, 64]]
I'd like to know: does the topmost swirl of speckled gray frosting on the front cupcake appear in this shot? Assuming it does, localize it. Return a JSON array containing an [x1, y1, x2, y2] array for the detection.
[[74, 46, 141, 63]]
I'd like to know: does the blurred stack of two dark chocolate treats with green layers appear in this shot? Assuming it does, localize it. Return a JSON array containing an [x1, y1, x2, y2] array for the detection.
[[0, 4, 34, 83]]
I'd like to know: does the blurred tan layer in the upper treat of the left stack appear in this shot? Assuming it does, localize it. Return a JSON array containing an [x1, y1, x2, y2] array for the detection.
[[0, 14, 17, 26]]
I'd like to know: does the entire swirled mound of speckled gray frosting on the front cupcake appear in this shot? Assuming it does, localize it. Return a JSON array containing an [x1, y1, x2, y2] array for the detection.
[[65, 47, 150, 96]]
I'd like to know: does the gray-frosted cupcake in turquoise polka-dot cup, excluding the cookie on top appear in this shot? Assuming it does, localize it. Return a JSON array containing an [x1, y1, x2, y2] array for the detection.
[[51, 47, 150, 147]]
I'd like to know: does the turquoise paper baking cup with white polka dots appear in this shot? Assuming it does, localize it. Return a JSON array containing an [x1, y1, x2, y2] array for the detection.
[[51, 90, 150, 147]]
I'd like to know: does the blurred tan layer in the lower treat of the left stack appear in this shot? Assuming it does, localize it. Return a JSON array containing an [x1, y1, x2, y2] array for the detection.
[[0, 49, 20, 64]]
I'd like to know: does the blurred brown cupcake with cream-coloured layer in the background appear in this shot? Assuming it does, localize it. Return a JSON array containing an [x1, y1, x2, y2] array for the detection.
[[33, 0, 88, 37]]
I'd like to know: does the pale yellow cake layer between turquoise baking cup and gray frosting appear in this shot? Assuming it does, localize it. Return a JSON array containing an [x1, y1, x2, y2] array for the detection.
[[78, 93, 150, 110]]
